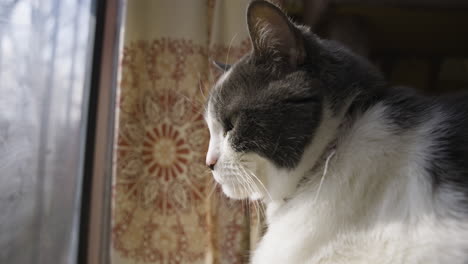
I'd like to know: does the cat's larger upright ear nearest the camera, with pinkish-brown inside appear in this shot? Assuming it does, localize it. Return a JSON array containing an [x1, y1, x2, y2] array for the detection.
[[247, 1, 305, 66]]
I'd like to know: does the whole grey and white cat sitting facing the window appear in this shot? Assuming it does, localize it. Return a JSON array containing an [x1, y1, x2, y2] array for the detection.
[[205, 0, 468, 264]]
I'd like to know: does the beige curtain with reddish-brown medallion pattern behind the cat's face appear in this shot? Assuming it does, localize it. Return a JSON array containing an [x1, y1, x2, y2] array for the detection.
[[111, 0, 264, 264]]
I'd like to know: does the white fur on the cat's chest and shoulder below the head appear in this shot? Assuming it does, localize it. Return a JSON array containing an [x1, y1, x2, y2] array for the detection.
[[251, 105, 468, 264]]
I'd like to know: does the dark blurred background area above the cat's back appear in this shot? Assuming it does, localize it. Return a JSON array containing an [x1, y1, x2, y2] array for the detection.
[[285, 0, 468, 94]]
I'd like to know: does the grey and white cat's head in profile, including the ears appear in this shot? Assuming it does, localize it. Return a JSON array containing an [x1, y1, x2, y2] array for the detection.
[[205, 1, 380, 199]]
